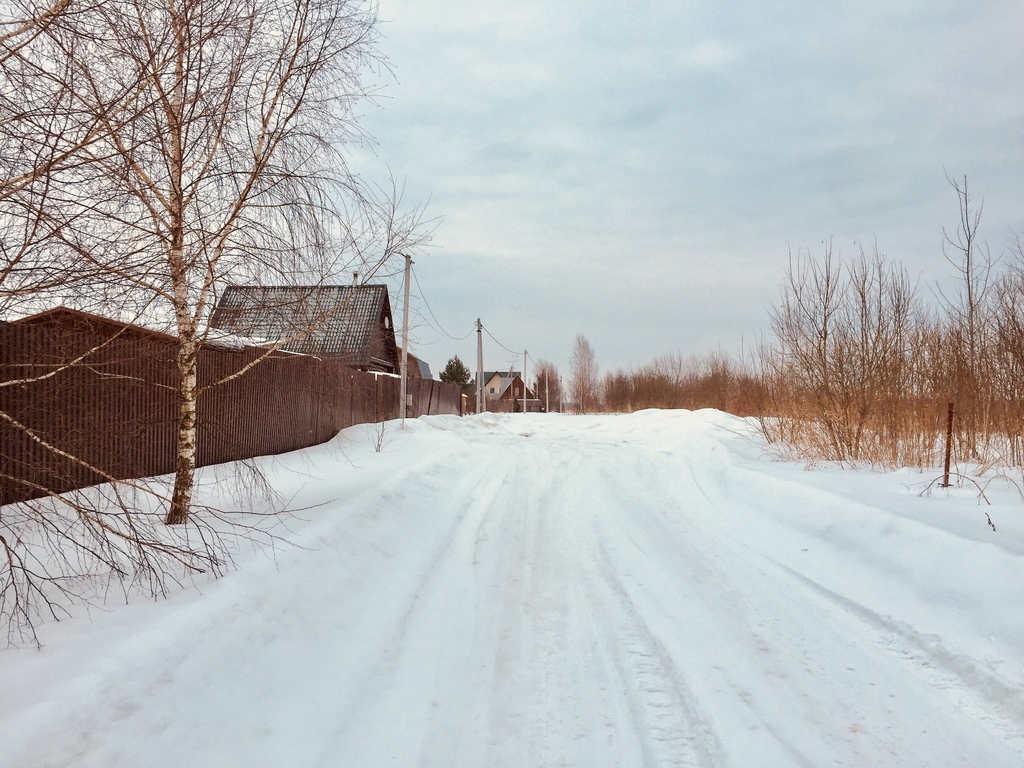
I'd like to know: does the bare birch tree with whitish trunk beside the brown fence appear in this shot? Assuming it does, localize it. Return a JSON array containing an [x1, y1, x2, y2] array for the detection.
[[0, 0, 425, 643]]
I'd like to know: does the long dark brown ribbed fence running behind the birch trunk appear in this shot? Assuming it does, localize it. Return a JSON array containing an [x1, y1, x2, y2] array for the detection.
[[0, 323, 461, 504]]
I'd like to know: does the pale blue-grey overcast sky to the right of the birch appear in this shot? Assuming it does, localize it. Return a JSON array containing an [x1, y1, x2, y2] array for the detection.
[[355, 0, 1024, 376]]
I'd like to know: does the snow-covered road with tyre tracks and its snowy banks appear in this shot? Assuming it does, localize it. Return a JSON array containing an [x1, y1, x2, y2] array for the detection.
[[0, 411, 1024, 768]]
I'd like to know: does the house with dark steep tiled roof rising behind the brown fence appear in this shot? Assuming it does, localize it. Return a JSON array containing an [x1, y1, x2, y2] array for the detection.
[[210, 285, 401, 374]]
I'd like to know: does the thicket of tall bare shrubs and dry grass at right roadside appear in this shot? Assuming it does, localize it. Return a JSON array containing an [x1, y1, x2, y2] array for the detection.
[[759, 179, 1024, 466]]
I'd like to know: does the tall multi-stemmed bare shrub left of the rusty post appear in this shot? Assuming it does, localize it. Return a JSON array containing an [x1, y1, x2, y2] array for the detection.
[[760, 243, 920, 462]]
